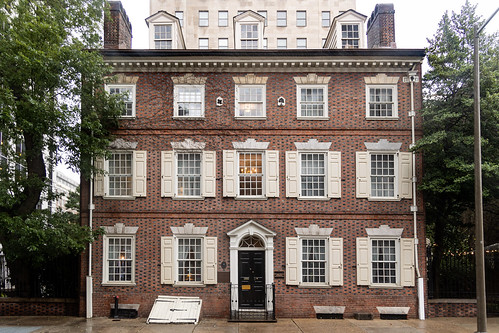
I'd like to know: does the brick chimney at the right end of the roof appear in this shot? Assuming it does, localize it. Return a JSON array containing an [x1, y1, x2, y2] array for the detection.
[[367, 3, 397, 49]]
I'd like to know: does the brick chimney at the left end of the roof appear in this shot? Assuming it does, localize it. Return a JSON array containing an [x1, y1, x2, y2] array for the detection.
[[104, 1, 132, 49]]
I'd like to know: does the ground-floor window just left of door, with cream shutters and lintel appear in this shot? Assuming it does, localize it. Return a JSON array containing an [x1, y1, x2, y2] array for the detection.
[[161, 223, 218, 286]]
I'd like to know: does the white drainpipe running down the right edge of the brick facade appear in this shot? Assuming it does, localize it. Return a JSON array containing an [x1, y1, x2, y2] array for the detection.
[[408, 65, 425, 320]]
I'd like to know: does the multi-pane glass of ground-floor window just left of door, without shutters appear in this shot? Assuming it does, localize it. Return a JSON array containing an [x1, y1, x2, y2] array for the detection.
[[178, 238, 202, 282]]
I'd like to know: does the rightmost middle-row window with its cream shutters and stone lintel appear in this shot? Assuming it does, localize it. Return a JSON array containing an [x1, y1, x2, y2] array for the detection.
[[356, 140, 413, 200]]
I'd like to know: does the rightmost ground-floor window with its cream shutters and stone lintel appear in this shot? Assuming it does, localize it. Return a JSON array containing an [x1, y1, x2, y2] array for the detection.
[[357, 225, 415, 287]]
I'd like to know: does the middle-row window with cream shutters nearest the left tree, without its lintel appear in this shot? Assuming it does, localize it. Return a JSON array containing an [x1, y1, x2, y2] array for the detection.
[[94, 150, 147, 198]]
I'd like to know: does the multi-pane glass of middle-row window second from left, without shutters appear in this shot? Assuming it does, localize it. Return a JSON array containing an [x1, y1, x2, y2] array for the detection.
[[177, 153, 201, 197]]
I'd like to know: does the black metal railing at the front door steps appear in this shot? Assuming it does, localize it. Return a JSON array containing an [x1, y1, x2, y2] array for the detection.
[[230, 283, 276, 321]]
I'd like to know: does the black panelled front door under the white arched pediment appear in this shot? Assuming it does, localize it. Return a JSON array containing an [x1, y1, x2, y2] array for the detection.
[[239, 251, 265, 309]]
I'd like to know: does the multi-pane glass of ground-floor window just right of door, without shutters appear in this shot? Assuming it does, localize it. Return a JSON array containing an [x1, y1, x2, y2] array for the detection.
[[301, 239, 326, 283]]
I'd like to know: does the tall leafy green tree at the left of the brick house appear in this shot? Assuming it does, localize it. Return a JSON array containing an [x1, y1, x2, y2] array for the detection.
[[0, 0, 122, 294]]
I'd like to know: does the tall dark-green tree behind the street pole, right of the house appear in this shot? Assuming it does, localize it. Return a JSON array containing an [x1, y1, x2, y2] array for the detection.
[[417, 1, 499, 290]]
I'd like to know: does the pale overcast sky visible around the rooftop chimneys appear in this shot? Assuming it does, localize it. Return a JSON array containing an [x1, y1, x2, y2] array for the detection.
[[121, 0, 499, 49]]
